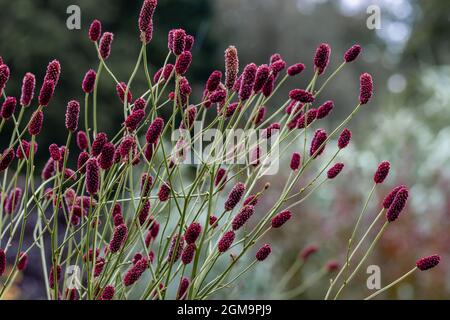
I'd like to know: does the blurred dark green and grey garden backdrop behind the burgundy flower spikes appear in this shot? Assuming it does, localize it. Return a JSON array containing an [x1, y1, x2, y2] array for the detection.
[[0, 0, 450, 299]]
